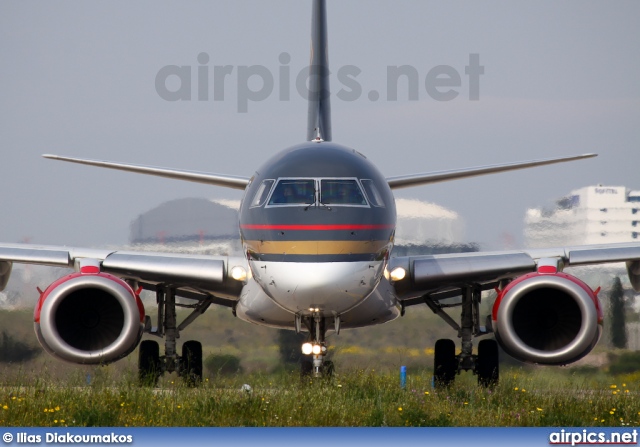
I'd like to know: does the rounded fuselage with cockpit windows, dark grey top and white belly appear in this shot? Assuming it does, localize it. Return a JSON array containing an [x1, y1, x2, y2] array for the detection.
[[235, 142, 396, 326]]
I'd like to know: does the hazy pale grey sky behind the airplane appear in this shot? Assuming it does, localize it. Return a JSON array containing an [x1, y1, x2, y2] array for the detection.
[[0, 0, 640, 248]]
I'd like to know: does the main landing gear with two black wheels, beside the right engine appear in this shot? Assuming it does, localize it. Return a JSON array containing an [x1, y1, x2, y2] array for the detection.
[[424, 287, 500, 387]]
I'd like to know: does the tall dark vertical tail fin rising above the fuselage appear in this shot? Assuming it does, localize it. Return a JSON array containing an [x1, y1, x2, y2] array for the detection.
[[307, 0, 331, 141]]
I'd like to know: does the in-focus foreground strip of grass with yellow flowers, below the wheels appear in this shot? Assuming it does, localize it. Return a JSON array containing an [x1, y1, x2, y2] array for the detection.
[[0, 367, 640, 427]]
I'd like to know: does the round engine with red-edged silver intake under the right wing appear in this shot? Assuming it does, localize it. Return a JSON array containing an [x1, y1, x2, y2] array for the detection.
[[492, 272, 602, 365]]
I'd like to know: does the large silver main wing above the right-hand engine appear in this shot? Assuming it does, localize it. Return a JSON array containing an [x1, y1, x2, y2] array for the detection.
[[388, 243, 640, 306]]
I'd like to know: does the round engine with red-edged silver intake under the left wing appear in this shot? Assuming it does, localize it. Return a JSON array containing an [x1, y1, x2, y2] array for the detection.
[[34, 269, 144, 364]]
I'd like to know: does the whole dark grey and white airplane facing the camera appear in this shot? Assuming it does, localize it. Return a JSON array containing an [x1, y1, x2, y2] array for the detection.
[[0, 0, 640, 386]]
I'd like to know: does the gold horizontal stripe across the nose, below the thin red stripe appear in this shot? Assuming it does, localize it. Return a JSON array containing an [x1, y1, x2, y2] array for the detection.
[[244, 241, 389, 255]]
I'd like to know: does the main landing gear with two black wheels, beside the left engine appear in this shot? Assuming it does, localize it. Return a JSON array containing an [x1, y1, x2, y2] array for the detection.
[[138, 287, 211, 387]]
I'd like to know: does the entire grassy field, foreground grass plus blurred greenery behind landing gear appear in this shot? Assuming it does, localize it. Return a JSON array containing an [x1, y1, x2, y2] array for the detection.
[[0, 308, 640, 427]]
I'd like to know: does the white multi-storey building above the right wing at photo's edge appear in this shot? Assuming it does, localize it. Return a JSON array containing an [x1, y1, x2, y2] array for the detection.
[[524, 185, 640, 248]]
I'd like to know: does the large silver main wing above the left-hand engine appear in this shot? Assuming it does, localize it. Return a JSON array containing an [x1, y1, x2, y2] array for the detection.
[[0, 244, 248, 307]]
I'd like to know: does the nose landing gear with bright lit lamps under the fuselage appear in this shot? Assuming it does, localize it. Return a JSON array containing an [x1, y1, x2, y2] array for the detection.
[[296, 312, 340, 378]]
